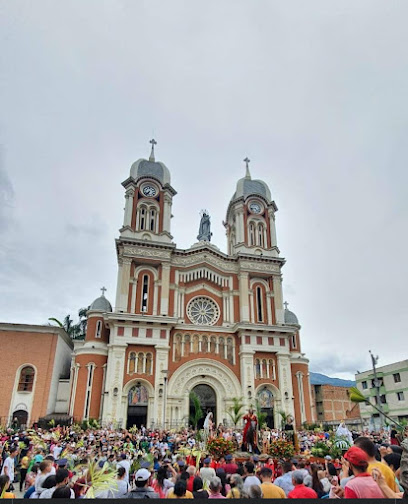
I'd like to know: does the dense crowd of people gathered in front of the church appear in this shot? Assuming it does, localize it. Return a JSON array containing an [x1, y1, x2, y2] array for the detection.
[[0, 426, 408, 499]]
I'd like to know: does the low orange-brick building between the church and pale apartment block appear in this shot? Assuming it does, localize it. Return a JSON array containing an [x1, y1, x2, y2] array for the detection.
[[312, 385, 361, 427]]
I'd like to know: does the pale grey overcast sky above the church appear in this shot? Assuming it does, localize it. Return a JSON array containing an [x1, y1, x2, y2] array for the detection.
[[0, 0, 408, 378]]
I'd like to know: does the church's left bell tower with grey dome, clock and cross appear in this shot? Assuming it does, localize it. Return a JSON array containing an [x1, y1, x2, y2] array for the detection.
[[120, 139, 176, 243]]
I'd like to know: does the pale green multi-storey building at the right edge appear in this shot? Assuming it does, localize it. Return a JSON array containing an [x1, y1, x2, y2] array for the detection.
[[356, 360, 408, 428]]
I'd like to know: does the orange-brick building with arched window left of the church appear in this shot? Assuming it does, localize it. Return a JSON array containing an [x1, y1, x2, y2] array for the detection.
[[0, 323, 74, 425]]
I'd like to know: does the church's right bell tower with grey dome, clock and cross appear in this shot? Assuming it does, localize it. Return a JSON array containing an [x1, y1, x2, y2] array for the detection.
[[224, 157, 279, 257]]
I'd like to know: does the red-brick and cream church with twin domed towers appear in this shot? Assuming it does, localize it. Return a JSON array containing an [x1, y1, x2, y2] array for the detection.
[[67, 140, 312, 428]]
